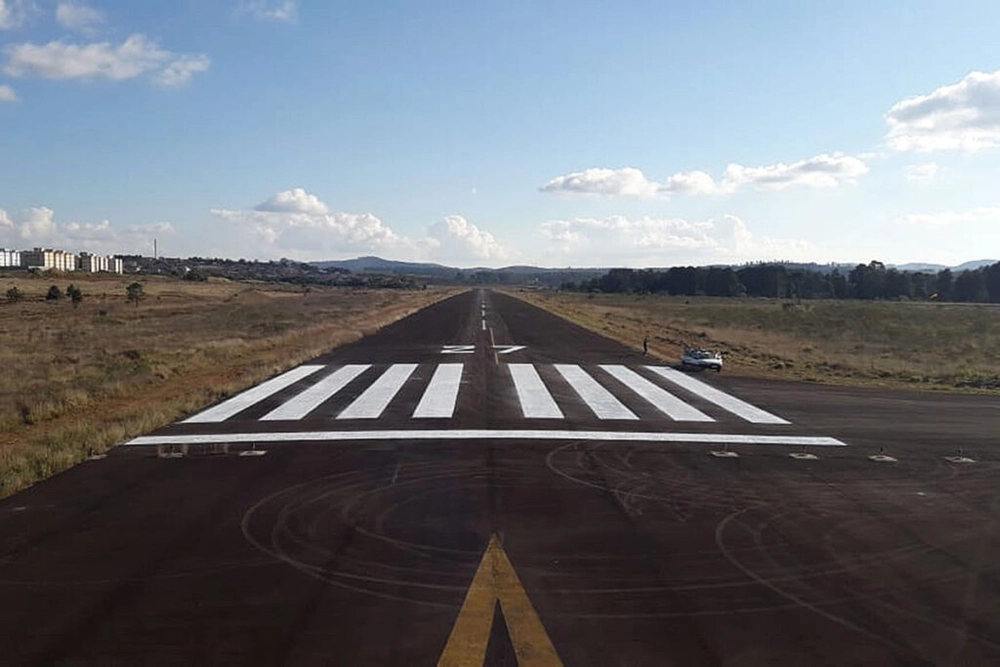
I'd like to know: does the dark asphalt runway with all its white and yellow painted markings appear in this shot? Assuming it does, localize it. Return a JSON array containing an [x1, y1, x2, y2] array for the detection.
[[0, 290, 1000, 666]]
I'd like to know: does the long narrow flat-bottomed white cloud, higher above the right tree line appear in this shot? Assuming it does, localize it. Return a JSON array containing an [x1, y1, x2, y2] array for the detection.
[[539, 153, 868, 198]]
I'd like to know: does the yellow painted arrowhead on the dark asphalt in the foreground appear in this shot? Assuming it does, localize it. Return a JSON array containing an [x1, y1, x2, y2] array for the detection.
[[438, 535, 563, 667]]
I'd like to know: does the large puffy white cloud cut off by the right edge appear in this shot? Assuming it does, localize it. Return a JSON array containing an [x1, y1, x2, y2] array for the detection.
[[885, 70, 1000, 152]]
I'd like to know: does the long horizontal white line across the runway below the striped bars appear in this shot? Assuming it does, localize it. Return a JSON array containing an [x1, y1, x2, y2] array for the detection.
[[125, 429, 847, 447]]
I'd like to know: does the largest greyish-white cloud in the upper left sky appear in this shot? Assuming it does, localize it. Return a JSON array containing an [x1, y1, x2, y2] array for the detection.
[[4, 33, 210, 86]]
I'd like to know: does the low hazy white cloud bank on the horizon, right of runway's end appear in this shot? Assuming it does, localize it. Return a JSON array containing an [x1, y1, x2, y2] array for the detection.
[[540, 215, 815, 266]]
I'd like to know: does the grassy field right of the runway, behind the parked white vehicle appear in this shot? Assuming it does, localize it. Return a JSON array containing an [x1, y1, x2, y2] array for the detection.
[[511, 291, 1000, 393]]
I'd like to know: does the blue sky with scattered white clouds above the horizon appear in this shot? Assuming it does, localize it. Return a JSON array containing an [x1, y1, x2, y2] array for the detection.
[[0, 0, 1000, 266]]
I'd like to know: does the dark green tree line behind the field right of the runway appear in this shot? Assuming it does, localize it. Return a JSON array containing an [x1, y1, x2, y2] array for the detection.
[[562, 261, 1000, 303]]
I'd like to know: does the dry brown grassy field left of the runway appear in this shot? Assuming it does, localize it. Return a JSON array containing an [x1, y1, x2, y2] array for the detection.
[[0, 273, 455, 497]]
